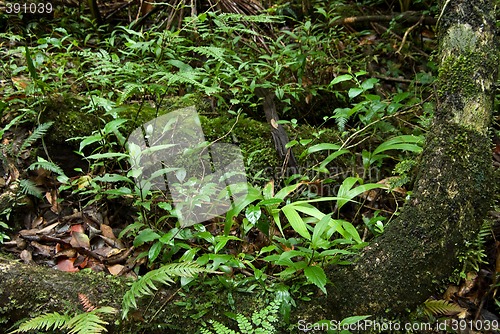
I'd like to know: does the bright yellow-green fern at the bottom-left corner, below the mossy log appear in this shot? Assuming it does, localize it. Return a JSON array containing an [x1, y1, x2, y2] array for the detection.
[[11, 307, 116, 334]]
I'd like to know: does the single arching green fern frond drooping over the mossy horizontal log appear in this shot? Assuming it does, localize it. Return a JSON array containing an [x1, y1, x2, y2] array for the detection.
[[122, 262, 210, 319]]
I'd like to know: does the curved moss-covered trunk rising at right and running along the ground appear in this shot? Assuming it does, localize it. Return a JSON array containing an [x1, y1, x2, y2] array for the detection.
[[0, 0, 498, 333]]
